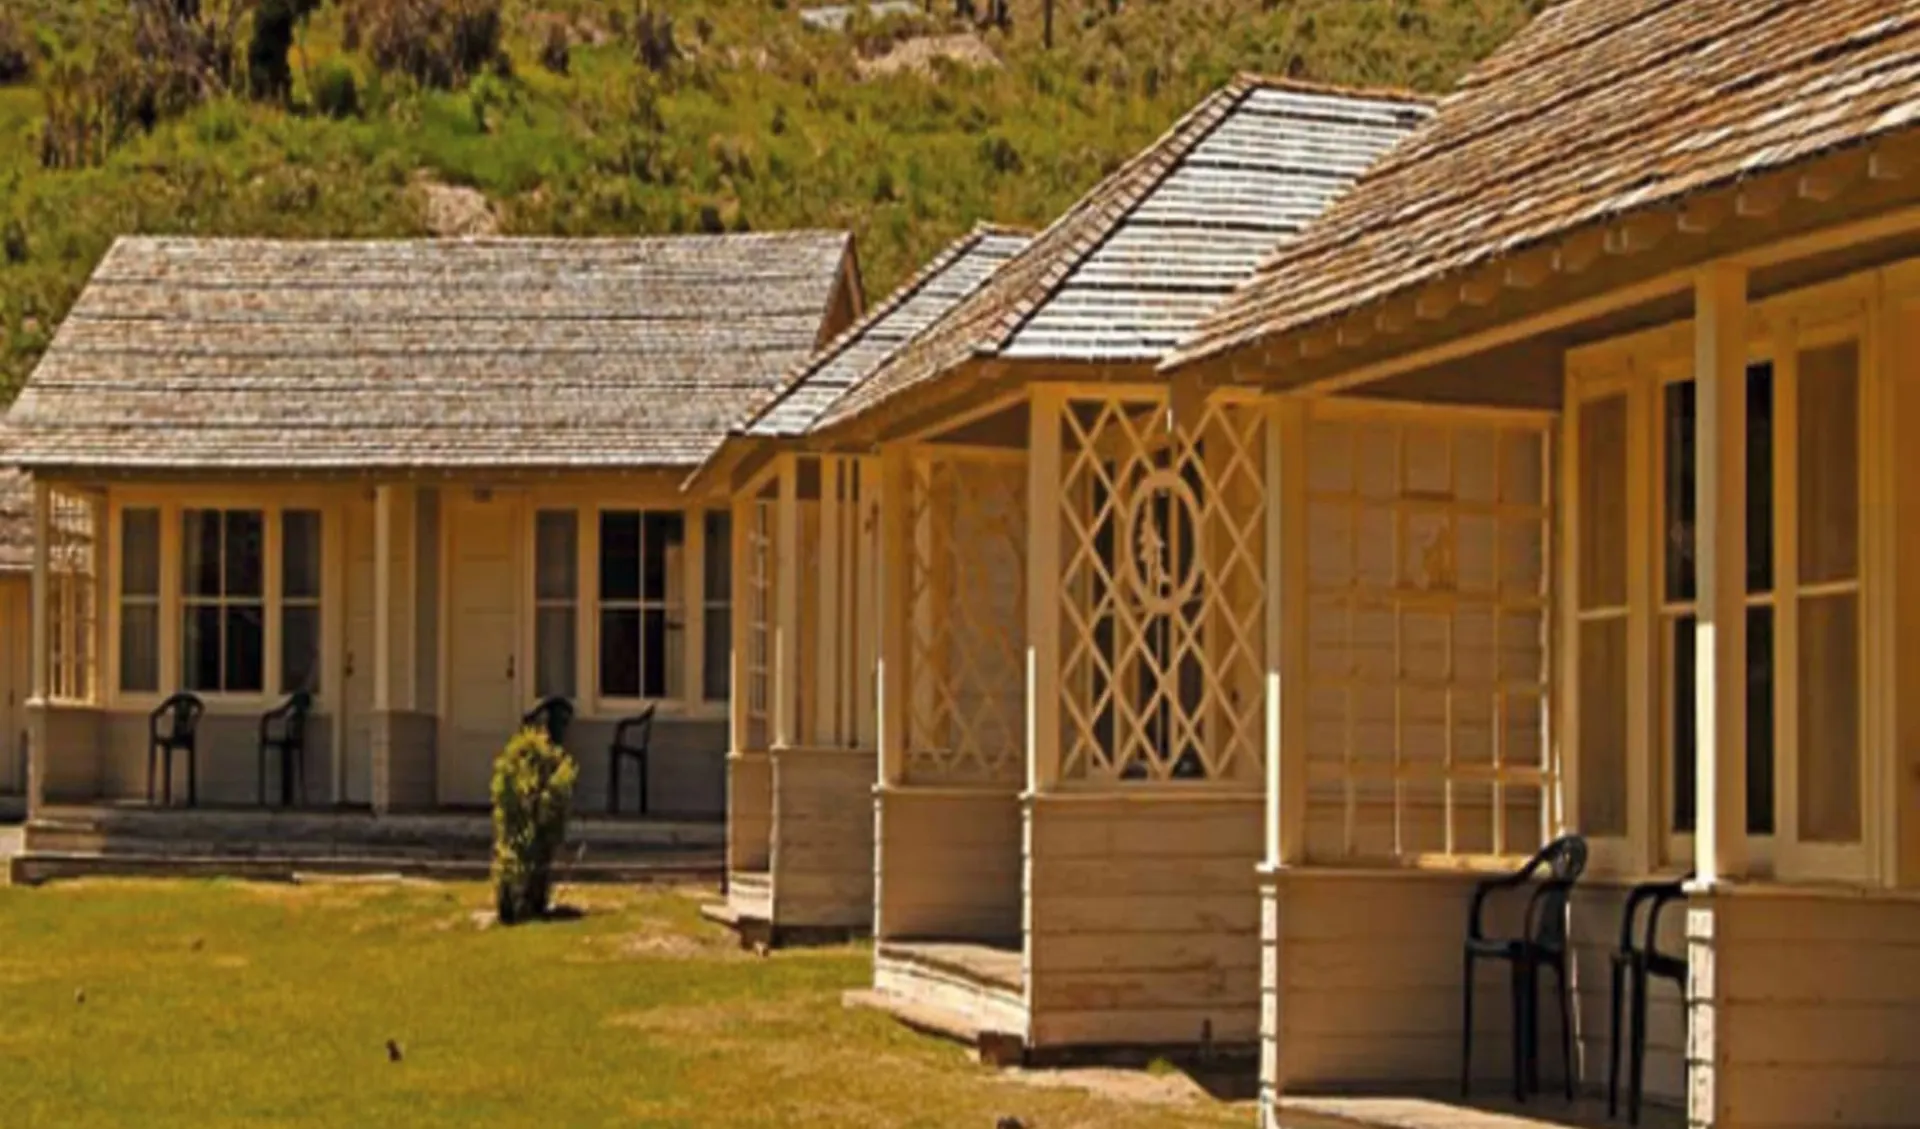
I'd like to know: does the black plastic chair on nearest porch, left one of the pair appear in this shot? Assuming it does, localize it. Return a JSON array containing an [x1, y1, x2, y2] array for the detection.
[[1459, 835, 1586, 1102]]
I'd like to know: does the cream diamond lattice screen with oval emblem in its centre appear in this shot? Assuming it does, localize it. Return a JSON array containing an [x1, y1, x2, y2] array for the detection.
[[1058, 396, 1269, 787]]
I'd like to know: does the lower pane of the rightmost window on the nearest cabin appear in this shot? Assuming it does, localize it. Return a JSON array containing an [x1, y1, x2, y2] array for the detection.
[[1799, 593, 1860, 843]]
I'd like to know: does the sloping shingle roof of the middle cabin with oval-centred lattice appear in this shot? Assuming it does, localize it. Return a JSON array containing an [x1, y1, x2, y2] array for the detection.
[[822, 77, 1430, 426]]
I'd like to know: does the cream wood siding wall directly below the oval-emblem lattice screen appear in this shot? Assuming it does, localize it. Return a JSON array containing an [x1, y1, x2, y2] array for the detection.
[[1025, 793, 1263, 1048]]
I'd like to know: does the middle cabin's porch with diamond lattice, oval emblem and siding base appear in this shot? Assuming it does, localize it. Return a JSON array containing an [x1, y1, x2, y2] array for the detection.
[[872, 378, 1275, 1062]]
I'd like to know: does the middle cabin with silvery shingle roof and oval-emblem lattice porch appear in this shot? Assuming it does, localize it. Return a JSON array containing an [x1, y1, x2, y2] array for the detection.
[[794, 79, 1428, 1058]]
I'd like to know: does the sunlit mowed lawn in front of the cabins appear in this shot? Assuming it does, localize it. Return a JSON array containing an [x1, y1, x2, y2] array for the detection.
[[0, 881, 1252, 1129]]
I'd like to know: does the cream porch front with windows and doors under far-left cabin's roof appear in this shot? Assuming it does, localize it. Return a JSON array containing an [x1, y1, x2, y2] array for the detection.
[[18, 470, 732, 824]]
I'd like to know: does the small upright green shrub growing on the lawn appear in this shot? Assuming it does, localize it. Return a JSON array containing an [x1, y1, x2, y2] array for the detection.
[[493, 730, 578, 925]]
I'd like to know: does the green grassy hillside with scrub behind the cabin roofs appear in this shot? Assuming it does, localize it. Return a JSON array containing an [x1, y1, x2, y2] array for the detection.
[[0, 0, 1546, 401]]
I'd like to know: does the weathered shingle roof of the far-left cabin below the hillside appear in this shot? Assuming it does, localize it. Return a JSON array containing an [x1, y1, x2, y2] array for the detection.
[[8, 232, 858, 470]]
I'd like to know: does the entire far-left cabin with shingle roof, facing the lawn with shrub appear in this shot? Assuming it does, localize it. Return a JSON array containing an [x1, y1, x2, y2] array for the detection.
[[10, 232, 860, 833]]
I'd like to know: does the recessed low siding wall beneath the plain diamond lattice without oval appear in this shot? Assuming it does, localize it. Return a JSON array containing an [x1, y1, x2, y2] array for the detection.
[[874, 787, 1021, 941]]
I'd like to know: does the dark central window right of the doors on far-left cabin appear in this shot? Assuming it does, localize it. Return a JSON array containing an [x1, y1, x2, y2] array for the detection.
[[599, 511, 685, 699]]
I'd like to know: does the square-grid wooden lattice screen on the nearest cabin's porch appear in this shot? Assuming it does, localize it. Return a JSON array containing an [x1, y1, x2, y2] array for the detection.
[[1306, 405, 1555, 860]]
